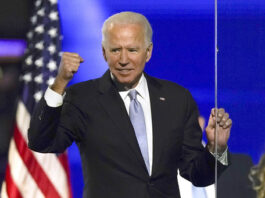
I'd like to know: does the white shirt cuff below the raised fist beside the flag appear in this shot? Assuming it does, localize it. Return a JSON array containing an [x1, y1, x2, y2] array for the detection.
[[44, 87, 65, 107]]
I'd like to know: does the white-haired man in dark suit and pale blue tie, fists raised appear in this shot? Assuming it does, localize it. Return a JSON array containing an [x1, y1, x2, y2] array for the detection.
[[29, 12, 232, 198]]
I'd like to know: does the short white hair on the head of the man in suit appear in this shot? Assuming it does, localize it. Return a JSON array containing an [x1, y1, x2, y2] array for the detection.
[[102, 12, 153, 46]]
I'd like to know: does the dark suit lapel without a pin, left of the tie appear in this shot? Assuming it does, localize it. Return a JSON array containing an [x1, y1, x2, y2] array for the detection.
[[96, 71, 147, 172]]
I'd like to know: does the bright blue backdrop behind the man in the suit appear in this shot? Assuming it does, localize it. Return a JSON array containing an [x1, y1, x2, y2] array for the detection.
[[59, 0, 265, 198]]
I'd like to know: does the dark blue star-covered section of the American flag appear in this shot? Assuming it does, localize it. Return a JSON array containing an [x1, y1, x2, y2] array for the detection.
[[20, 0, 61, 105]]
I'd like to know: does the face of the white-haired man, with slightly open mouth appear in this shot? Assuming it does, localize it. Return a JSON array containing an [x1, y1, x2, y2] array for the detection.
[[102, 24, 153, 88]]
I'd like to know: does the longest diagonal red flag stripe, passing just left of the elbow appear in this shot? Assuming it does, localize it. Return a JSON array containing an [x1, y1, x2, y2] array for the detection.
[[14, 126, 60, 198]]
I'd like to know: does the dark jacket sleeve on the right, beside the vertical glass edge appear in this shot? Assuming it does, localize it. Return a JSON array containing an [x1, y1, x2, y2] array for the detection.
[[176, 91, 226, 186]]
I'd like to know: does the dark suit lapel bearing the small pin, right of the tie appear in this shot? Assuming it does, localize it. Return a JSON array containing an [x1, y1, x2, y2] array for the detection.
[[146, 75, 167, 176]]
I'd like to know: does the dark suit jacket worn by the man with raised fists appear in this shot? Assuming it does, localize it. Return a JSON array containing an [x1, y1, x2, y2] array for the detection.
[[28, 71, 224, 198]]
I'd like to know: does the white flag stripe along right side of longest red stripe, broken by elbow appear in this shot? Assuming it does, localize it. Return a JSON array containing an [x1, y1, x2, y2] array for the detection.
[[17, 101, 70, 197]]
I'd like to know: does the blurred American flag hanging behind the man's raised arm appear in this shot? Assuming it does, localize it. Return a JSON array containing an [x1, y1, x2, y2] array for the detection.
[[1, 0, 72, 198]]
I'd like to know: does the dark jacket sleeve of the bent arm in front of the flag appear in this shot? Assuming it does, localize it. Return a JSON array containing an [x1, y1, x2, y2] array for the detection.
[[28, 90, 83, 153]]
